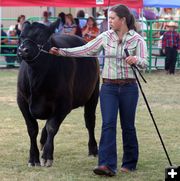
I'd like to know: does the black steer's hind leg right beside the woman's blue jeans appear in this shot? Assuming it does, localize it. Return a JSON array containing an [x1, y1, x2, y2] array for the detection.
[[84, 80, 99, 156]]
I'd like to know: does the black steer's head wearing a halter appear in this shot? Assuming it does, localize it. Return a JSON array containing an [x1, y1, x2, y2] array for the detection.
[[18, 19, 59, 63]]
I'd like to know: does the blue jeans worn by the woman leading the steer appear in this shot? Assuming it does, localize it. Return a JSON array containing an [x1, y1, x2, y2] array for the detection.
[[98, 83, 139, 172]]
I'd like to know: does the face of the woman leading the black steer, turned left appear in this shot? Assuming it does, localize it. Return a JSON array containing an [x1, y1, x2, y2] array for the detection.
[[109, 11, 124, 31]]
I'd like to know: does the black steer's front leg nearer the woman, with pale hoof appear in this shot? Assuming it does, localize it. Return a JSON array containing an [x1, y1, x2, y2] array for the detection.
[[41, 115, 66, 167]]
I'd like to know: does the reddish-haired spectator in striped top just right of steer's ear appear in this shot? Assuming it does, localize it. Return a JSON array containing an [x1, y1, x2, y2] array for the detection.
[[62, 13, 77, 35]]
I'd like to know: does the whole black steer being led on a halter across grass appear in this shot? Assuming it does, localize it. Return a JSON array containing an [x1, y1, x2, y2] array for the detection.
[[17, 22, 99, 167]]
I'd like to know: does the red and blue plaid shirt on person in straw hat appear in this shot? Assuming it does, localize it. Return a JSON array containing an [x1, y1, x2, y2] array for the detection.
[[162, 31, 180, 49]]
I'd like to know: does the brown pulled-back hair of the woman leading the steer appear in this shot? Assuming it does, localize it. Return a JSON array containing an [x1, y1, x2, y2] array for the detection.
[[110, 4, 136, 31]]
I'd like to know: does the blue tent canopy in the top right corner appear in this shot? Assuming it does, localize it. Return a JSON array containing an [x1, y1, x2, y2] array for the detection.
[[143, 0, 180, 8]]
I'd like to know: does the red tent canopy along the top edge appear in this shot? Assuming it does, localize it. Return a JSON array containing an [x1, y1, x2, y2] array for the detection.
[[0, 0, 143, 8]]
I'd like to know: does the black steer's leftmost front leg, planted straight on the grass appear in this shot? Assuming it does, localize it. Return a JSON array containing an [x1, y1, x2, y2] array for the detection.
[[17, 95, 40, 166]]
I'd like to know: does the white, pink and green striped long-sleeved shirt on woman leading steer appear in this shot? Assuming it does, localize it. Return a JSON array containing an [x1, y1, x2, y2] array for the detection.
[[59, 30, 147, 79]]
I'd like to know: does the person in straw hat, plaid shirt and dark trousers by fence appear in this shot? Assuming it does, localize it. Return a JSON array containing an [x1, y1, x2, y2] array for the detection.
[[162, 21, 180, 74]]
